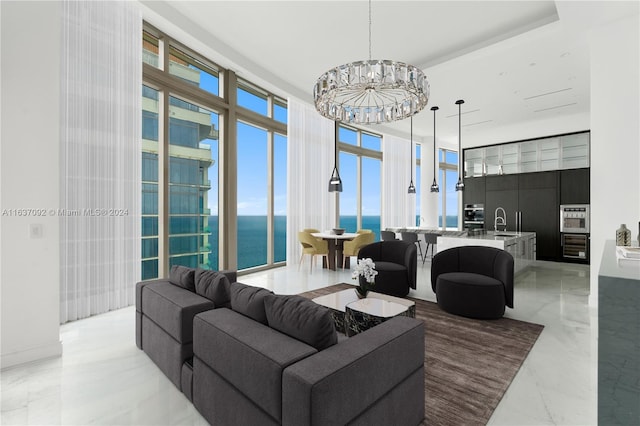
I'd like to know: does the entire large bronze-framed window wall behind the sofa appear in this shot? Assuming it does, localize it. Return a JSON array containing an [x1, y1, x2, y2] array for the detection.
[[141, 25, 287, 279]]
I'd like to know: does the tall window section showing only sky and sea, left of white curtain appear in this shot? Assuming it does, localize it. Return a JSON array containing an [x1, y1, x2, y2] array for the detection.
[[236, 80, 287, 269]]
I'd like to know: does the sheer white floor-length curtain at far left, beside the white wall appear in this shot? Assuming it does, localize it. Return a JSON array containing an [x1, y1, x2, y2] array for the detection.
[[60, 1, 142, 323]]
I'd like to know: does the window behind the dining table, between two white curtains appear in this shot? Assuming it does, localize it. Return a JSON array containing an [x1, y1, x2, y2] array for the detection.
[[338, 125, 382, 239]]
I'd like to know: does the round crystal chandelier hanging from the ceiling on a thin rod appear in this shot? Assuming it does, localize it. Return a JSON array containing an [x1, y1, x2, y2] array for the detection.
[[313, 0, 429, 124]]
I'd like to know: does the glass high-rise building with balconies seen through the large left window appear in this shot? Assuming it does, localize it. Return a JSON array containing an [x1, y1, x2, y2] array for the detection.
[[141, 44, 218, 280]]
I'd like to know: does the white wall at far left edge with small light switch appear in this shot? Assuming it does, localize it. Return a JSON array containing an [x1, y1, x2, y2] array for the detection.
[[0, 1, 62, 368]]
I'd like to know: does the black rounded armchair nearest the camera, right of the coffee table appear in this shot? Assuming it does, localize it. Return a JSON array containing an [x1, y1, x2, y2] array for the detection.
[[431, 246, 513, 319]]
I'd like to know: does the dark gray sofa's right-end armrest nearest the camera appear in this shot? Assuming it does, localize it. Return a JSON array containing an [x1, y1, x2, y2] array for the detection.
[[282, 317, 424, 426]]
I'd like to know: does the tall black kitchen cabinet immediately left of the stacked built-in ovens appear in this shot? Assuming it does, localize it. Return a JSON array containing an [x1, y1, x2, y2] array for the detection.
[[518, 171, 560, 260]]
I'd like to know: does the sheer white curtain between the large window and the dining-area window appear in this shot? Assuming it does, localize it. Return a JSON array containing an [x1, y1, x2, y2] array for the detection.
[[287, 98, 336, 265]]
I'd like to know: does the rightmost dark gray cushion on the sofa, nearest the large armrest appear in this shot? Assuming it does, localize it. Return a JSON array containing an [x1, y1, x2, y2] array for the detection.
[[264, 294, 338, 351]]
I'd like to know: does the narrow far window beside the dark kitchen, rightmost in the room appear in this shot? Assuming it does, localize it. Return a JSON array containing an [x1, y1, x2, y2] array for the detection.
[[438, 149, 458, 229]]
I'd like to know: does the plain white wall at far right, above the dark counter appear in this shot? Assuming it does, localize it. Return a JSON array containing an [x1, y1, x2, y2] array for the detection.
[[589, 15, 640, 306]]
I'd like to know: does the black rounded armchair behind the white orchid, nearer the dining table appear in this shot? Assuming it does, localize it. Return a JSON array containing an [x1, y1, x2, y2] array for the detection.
[[358, 240, 418, 297]]
